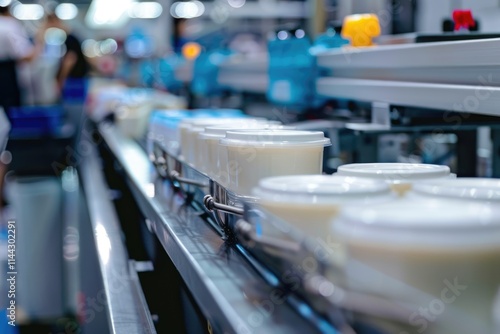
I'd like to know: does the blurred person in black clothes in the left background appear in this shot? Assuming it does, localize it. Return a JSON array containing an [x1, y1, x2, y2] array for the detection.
[[45, 14, 90, 99]]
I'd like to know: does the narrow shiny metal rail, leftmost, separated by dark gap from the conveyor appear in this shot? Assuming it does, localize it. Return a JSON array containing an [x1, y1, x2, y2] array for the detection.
[[81, 137, 156, 334]]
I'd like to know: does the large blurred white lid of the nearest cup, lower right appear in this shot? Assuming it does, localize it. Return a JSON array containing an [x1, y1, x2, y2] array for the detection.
[[334, 199, 500, 249]]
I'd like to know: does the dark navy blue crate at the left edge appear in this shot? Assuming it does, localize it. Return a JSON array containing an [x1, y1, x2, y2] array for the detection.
[[9, 106, 64, 136]]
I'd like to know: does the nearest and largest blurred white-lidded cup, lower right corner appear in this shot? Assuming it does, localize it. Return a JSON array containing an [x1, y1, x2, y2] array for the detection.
[[333, 198, 500, 334]]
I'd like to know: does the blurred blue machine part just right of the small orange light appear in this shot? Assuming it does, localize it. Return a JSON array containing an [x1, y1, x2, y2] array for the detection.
[[191, 49, 231, 96]]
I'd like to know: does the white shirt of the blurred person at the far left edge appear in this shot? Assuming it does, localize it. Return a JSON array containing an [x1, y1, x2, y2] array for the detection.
[[0, 15, 33, 60]]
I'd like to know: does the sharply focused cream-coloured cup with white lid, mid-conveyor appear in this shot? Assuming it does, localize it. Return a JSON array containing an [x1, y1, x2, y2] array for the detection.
[[219, 130, 330, 196]]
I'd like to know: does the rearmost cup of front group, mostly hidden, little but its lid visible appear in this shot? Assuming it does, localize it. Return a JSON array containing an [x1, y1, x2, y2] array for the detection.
[[335, 163, 456, 196]]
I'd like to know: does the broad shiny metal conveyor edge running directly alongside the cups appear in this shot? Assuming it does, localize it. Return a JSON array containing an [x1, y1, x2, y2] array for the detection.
[[99, 124, 326, 333]]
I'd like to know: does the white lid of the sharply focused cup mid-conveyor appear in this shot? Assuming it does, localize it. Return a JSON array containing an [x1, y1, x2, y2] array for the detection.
[[219, 130, 331, 147]]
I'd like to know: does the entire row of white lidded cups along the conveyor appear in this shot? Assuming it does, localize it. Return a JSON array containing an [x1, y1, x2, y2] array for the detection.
[[150, 110, 500, 333]]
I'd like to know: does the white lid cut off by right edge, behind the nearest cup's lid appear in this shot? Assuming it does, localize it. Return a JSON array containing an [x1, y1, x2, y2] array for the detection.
[[413, 178, 500, 202]]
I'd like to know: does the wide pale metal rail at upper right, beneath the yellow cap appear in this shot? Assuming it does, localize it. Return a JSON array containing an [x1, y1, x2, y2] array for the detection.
[[316, 38, 500, 116]]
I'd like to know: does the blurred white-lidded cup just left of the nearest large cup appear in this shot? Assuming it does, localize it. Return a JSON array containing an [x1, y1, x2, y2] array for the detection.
[[252, 175, 396, 240]]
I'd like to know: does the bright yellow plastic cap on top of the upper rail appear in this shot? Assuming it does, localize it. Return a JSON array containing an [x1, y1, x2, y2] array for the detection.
[[342, 14, 380, 46]]
